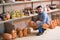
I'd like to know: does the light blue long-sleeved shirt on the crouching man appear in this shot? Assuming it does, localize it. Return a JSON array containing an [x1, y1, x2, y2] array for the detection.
[[33, 12, 51, 25]]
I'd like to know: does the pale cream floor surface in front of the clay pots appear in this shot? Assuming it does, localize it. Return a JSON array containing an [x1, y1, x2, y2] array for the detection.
[[15, 26, 60, 40]]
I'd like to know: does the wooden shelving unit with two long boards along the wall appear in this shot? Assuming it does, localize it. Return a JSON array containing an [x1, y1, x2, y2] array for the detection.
[[0, 0, 60, 34]]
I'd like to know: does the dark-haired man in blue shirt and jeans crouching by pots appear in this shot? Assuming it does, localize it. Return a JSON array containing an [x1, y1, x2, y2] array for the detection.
[[33, 6, 50, 35]]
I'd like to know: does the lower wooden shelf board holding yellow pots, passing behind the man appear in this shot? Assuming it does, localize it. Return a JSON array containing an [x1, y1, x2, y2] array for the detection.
[[0, 9, 60, 24]]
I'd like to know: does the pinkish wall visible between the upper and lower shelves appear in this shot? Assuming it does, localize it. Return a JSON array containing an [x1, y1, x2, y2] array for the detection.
[[0, 1, 60, 13]]
